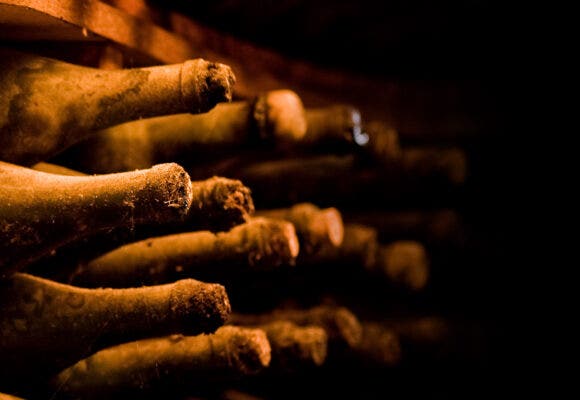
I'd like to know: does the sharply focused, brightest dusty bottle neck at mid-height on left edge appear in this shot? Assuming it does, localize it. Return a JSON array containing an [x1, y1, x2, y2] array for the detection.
[[0, 161, 192, 276]]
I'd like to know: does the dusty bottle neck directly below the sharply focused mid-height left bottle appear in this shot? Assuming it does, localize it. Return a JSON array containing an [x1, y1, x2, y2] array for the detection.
[[72, 218, 299, 287]]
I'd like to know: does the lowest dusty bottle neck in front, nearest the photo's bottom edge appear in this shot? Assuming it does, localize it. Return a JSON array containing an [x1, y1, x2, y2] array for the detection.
[[52, 326, 271, 399]]
